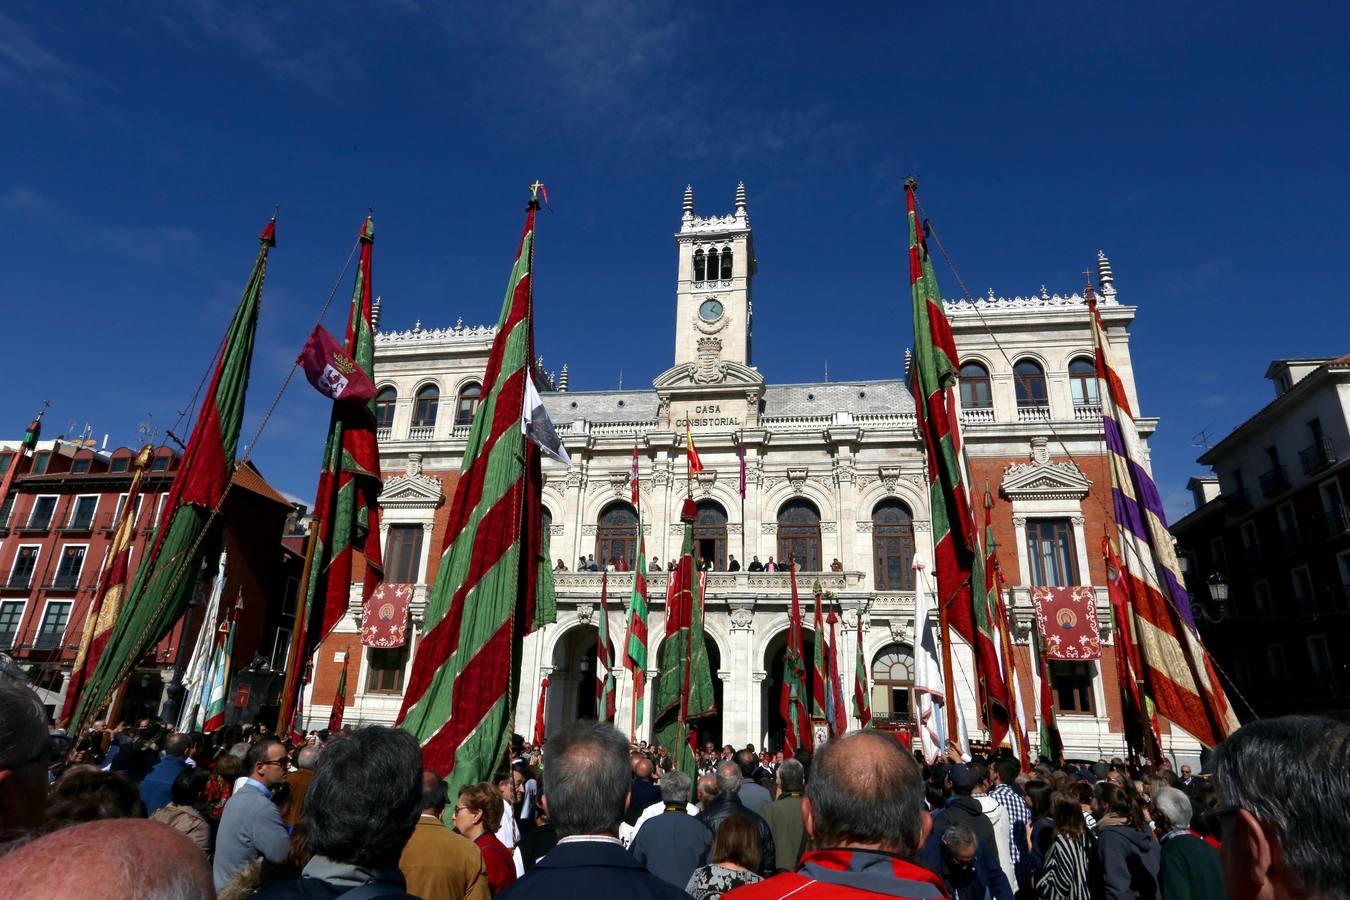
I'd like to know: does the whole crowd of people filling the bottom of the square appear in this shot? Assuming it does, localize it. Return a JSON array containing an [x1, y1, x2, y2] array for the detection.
[[0, 680, 1350, 900]]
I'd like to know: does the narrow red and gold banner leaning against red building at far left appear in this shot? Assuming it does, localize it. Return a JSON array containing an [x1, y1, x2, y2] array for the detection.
[[59, 444, 153, 727]]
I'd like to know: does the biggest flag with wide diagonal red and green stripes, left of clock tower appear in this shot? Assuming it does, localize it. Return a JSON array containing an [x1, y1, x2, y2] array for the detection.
[[398, 186, 556, 795]]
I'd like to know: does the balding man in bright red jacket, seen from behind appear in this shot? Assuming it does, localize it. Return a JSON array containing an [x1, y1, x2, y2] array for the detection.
[[734, 731, 946, 900]]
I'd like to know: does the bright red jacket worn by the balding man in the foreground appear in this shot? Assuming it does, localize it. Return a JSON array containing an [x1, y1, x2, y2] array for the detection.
[[722, 849, 948, 900]]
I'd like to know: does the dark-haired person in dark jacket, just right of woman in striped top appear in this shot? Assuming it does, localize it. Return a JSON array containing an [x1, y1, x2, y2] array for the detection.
[[1092, 781, 1162, 900]]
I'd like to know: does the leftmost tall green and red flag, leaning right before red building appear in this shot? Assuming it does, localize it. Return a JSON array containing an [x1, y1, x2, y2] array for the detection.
[[72, 219, 277, 730]]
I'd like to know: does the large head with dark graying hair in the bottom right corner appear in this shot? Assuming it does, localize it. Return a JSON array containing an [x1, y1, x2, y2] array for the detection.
[[1212, 715, 1350, 900]]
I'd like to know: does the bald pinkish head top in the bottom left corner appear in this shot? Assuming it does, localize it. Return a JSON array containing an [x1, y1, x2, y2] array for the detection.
[[0, 819, 216, 900]]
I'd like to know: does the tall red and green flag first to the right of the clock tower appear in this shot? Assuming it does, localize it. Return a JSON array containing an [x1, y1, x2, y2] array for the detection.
[[905, 178, 983, 644]]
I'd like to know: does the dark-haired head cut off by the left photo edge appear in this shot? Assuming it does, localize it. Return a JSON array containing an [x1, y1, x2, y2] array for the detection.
[[0, 677, 51, 841]]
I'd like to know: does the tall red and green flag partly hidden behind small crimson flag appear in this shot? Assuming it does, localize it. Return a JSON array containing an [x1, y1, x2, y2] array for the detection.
[[277, 216, 383, 734]]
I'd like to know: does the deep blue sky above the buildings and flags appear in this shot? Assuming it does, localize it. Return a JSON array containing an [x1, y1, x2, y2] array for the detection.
[[0, 0, 1350, 514]]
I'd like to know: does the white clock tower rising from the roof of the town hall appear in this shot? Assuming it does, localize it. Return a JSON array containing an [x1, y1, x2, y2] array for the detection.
[[675, 182, 755, 374]]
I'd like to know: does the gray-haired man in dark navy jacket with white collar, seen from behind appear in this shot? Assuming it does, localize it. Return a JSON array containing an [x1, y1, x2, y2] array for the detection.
[[500, 722, 689, 900]]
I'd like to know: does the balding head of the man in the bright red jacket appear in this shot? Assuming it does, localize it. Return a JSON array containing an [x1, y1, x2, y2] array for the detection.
[[806, 731, 925, 855]]
